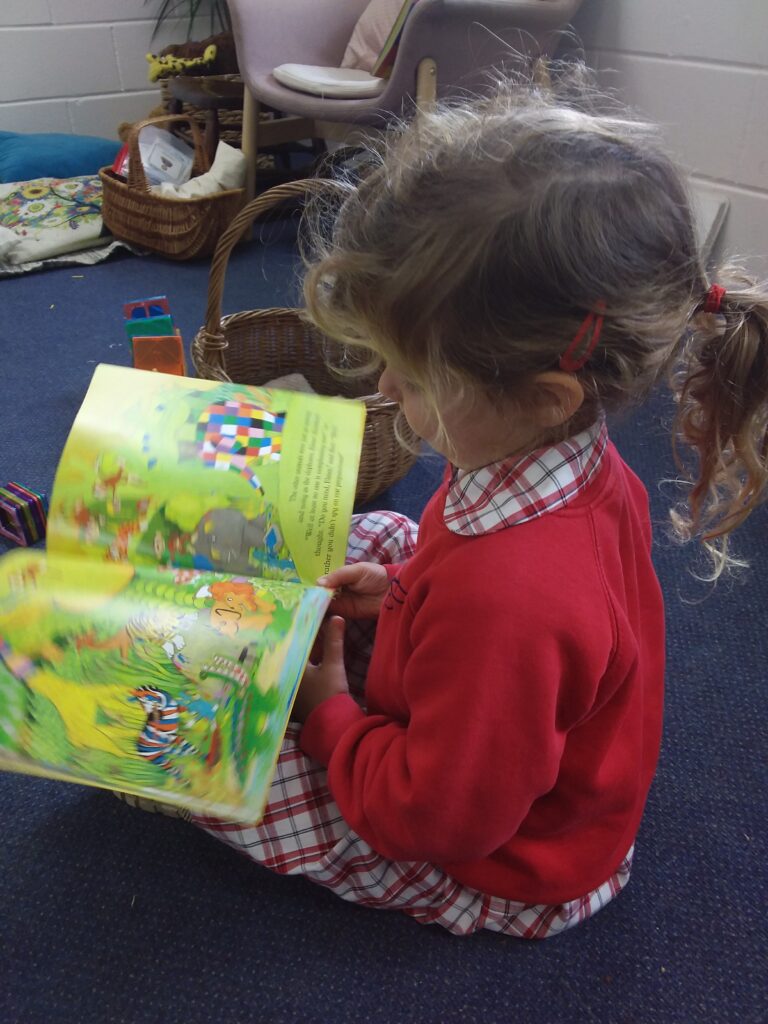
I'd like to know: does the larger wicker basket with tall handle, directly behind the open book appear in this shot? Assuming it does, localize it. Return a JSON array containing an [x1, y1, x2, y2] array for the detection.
[[191, 178, 418, 502]]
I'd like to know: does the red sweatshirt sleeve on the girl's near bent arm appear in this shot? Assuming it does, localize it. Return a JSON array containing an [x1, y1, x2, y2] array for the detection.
[[301, 577, 602, 863]]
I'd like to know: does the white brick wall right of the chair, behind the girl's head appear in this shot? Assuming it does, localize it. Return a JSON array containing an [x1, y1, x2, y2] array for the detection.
[[575, 0, 768, 278]]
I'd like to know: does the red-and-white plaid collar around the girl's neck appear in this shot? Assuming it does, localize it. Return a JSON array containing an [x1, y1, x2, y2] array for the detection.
[[443, 418, 608, 537]]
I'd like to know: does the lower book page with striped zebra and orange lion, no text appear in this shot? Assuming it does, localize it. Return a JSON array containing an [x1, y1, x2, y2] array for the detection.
[[0, 551, 330, 821]]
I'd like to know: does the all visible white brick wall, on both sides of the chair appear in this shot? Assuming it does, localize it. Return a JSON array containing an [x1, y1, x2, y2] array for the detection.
[[0, 0, 768, 276]]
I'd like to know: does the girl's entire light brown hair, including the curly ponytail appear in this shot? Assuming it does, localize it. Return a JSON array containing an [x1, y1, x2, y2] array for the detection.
[[304, 72, 768, 574]]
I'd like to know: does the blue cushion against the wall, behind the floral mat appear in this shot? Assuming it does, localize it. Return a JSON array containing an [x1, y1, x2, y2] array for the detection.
[[0, 131, 122, 183]]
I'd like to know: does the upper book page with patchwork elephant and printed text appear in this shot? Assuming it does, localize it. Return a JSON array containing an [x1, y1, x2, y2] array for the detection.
[[47, 365, 366, 584]]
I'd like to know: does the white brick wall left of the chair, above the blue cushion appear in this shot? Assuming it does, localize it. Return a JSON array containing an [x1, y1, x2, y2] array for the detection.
[[0, 0, 191, 138]]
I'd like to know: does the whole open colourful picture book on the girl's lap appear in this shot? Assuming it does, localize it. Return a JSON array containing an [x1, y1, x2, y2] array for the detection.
[[0, 366, 365, 820]]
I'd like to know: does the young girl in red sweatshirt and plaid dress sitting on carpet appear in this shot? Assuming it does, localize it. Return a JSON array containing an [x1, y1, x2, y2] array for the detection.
[[189, 74, 768, 938]]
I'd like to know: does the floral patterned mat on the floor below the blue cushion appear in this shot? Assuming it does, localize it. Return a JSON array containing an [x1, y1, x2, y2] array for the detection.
[[0, 175, 129, 274]]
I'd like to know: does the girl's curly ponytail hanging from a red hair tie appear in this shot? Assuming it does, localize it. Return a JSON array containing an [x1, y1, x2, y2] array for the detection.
[[672, 278, 768, 579]]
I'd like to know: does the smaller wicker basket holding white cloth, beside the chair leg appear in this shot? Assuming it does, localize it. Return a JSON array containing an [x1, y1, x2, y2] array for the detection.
[[98, 115, 246, 259]]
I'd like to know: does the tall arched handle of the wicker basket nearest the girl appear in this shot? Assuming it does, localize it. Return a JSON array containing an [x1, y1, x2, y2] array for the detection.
[[200, 178, 342, 361]]
